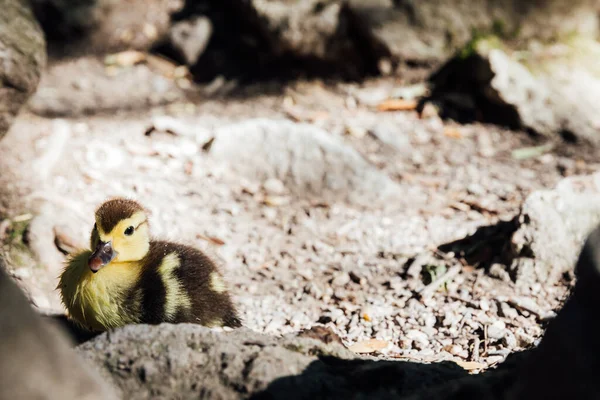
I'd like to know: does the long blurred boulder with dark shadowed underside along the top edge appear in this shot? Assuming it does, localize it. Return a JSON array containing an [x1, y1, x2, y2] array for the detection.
[[166, 0, 598, 80]]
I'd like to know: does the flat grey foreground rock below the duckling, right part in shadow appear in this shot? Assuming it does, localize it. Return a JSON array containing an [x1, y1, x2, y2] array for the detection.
[[78, 324, 467, 400]]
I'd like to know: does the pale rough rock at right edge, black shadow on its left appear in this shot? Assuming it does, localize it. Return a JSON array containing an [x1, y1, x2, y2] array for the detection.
[[439, 173, 600, 288]]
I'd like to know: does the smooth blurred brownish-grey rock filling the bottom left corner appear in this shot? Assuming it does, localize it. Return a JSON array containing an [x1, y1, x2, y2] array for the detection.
[[0, 259, 117, 400]]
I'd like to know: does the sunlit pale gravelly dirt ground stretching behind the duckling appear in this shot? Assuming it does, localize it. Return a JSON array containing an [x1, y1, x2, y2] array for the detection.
[[0, 54, 597, 366]]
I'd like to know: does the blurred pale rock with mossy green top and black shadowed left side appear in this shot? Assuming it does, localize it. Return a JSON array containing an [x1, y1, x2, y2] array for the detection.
[[431, 38, 600, 146]]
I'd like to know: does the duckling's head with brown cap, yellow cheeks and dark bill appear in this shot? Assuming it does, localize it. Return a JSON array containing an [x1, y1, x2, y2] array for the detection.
[[88, 198, 150, 273]]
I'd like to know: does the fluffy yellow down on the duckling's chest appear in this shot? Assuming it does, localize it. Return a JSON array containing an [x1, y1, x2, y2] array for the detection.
[[58, 250, 142, 331]]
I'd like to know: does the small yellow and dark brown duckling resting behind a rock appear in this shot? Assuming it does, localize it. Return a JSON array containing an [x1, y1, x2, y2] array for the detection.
[[57, 198, 241, 331]]
